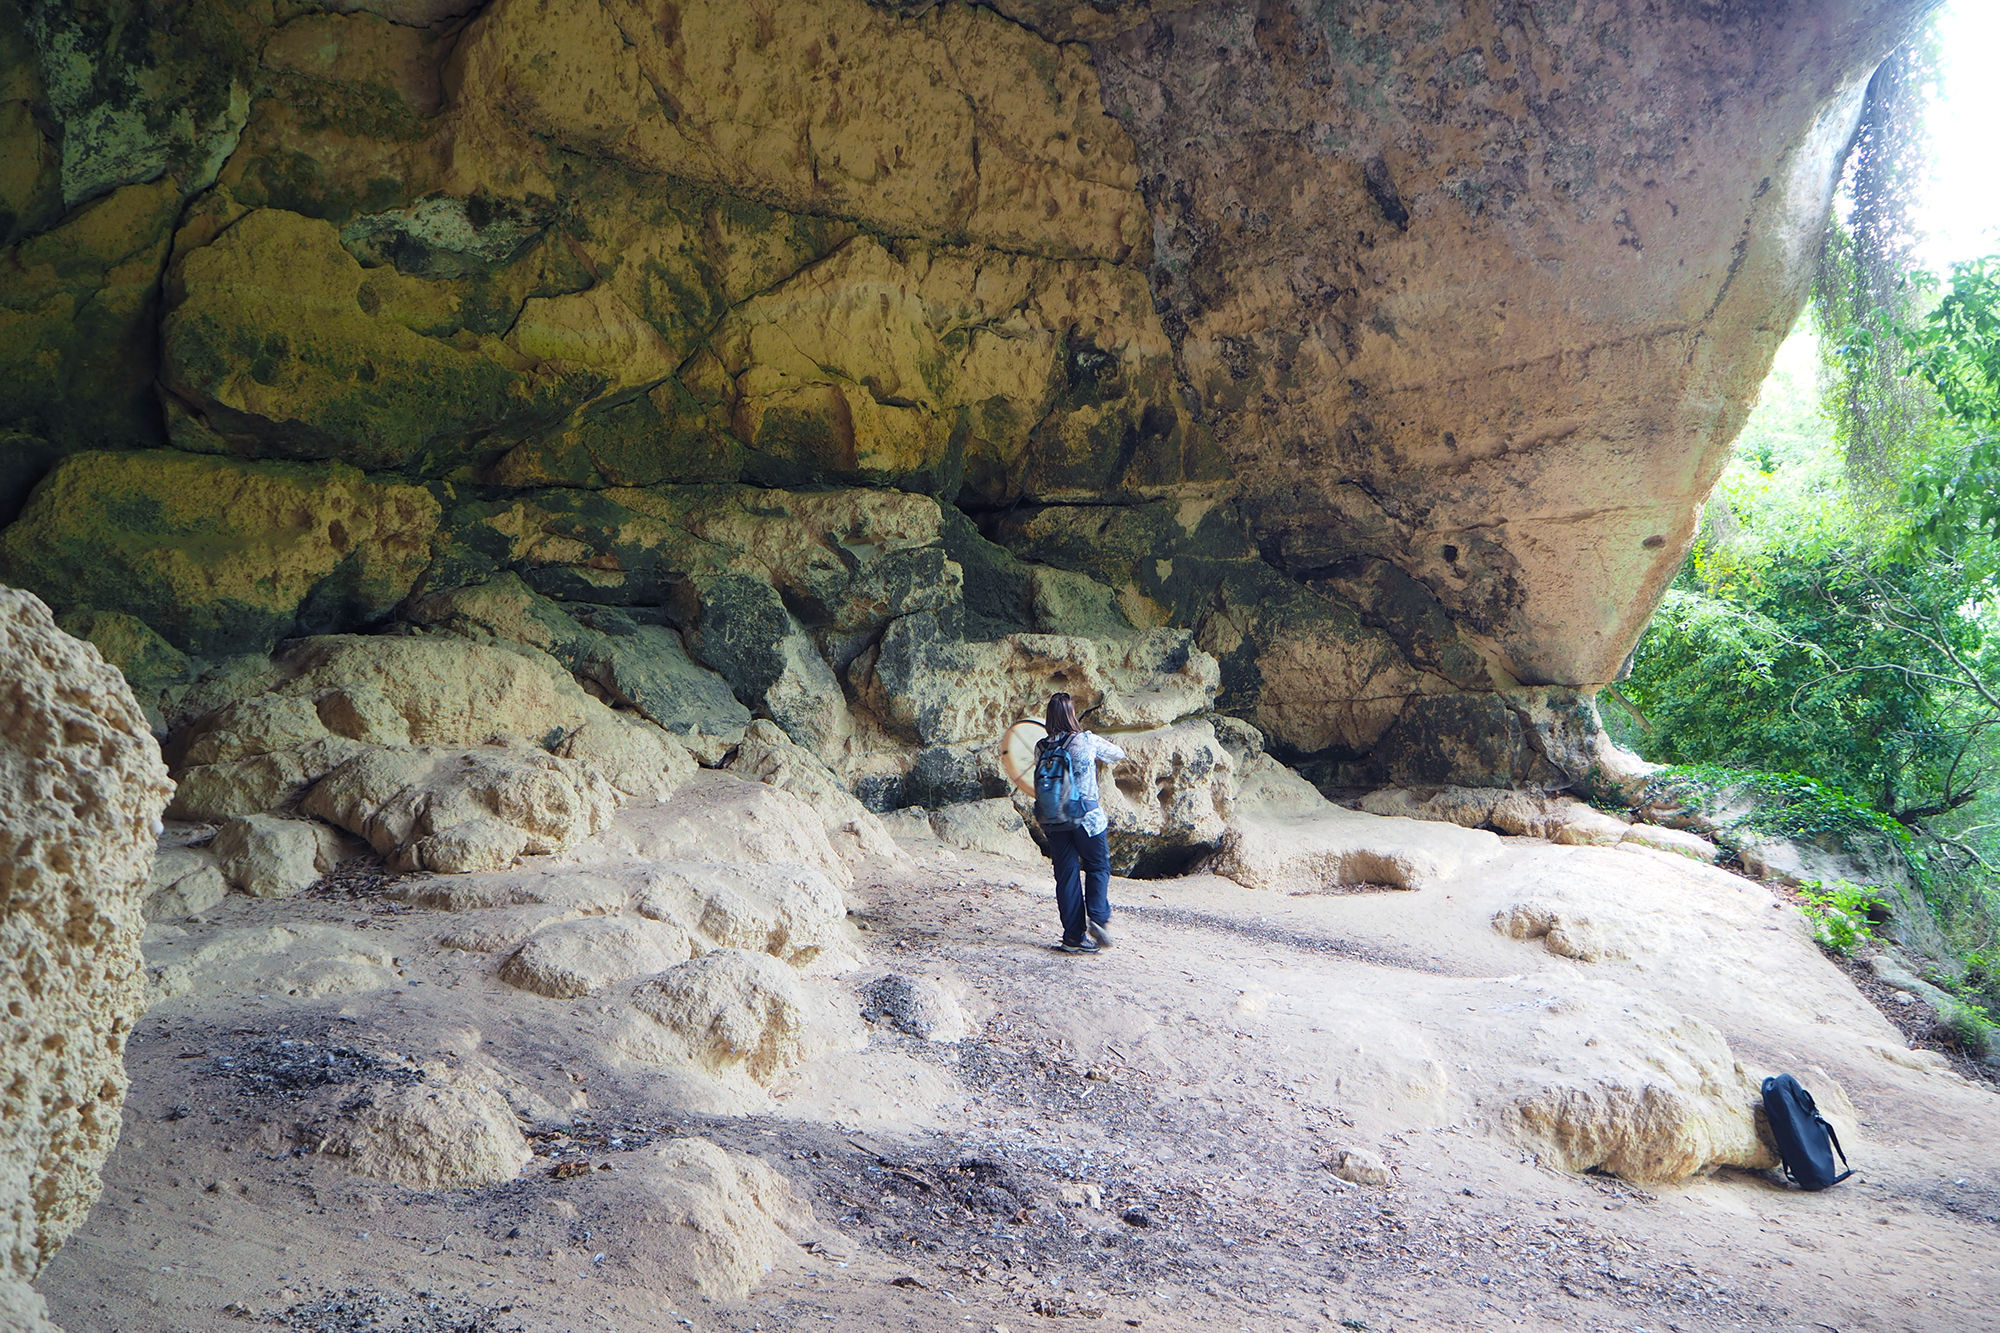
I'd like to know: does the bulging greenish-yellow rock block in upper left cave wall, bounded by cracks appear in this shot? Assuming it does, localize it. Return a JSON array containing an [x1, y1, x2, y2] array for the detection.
[[160, 208, 676, 474]]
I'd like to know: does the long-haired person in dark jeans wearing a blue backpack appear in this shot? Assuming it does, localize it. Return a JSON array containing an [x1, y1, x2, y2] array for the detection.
[[1034, 693, 1126, 953]]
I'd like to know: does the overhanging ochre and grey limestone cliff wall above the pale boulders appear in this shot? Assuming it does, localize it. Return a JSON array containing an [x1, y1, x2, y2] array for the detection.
[[0, 0, 1922, 784]]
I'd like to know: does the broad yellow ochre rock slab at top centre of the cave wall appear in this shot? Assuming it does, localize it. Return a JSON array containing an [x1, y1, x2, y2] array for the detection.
[[452, 0, 1150, 260]]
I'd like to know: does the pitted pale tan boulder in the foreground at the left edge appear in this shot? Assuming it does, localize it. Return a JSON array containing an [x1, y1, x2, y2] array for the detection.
[[0, 588, 172, 1329]]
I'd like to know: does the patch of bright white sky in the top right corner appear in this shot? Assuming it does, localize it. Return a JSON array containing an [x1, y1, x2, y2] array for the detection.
[[1916, 0, 2000, 274]]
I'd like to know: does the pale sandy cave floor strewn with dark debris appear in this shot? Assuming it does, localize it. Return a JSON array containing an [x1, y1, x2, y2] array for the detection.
[[38, 808, 2000, 1333]]
